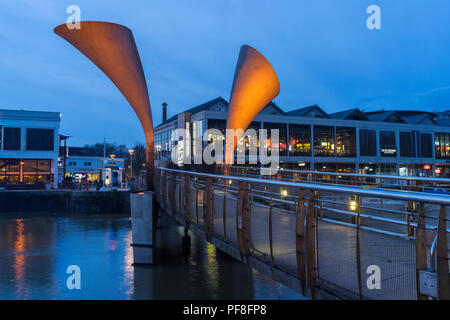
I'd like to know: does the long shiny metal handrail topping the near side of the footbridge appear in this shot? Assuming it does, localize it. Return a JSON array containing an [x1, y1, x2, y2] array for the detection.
[[158, 167, 450, 205]]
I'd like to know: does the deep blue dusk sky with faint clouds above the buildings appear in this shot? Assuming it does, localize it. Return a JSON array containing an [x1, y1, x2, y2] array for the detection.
[[0, 0, 450, 146]]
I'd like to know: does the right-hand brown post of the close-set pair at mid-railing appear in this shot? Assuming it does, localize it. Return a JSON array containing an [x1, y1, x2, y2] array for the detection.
[[306, 191, 317, 299]]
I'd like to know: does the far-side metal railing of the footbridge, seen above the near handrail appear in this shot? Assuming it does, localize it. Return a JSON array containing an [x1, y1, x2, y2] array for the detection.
[[219, 166, 450, 195]]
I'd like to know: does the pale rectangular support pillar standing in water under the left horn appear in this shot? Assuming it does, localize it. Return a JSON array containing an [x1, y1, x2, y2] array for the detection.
[[130, 191, 158, 264]]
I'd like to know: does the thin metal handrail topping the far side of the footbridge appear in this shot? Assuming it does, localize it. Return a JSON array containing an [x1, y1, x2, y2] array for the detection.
[[224, 166, 450, 183]]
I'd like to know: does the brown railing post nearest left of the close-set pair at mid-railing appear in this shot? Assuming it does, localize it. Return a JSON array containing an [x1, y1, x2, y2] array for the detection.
[[236, 182, 250, 264]]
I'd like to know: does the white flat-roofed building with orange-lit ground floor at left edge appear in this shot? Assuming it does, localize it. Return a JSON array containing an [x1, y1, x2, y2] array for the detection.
[[0, 109, 61, 188]]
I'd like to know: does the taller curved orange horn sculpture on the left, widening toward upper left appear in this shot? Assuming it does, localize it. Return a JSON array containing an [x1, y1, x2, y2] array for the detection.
[[54, 21, 154, 190]]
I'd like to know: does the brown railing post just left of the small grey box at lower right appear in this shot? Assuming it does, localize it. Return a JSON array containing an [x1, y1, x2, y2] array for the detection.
[[416, 202, 428, 300]]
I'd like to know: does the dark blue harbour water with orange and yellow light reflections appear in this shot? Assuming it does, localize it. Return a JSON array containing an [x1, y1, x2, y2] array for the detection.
[[0, 215, 299, 299]]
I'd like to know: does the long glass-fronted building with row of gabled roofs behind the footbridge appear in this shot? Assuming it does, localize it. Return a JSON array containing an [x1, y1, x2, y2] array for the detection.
[[155, 97, 450, 177]]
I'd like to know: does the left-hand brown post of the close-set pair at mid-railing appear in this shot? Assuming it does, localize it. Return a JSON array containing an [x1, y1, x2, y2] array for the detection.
[[295, 190, 306, 295]]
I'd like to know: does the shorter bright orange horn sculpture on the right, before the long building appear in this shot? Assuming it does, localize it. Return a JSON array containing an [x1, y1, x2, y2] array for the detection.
[[225, 45, 280, 165]]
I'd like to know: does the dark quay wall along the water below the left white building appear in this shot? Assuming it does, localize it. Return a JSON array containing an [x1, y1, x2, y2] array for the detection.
[[0, 190, 130, 214]]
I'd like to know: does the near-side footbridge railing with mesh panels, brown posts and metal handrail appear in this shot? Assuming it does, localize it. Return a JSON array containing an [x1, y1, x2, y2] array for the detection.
[[155, 168, 450, 299]]
